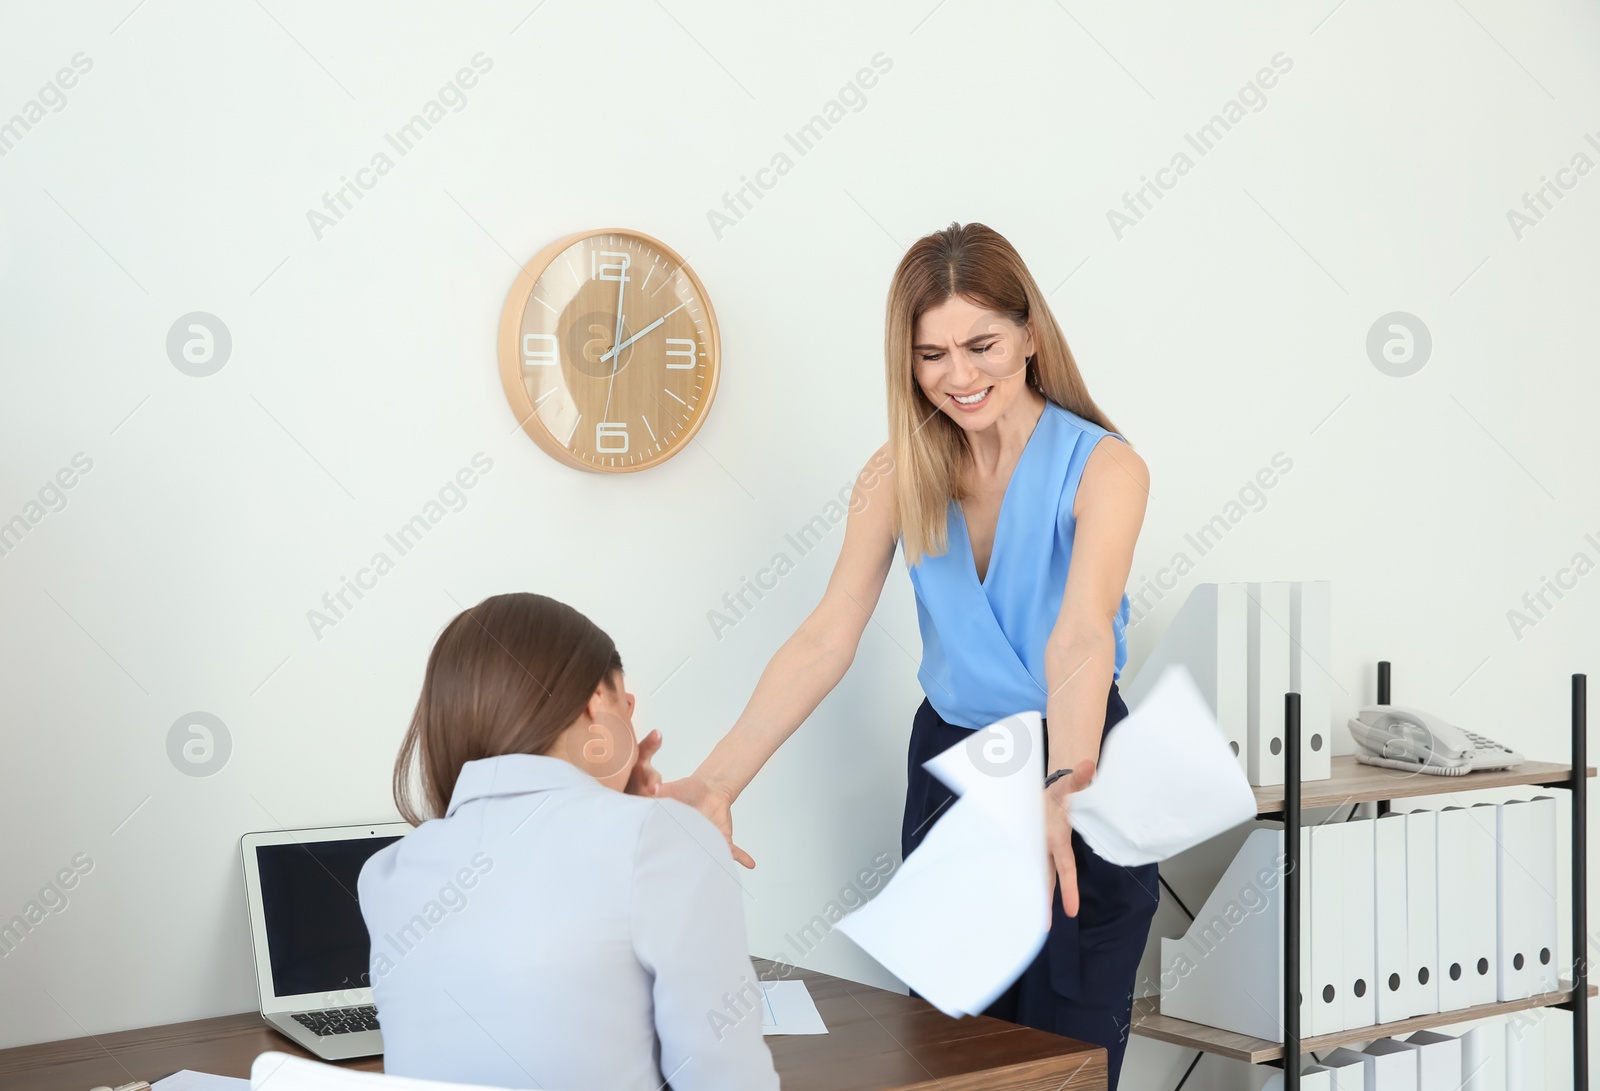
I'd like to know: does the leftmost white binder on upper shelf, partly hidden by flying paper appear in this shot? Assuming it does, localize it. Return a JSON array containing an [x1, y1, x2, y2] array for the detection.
[[1123, 584, 1248, 776]]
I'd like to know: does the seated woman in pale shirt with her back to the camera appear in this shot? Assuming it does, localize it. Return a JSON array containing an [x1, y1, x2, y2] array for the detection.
[[358, 593, 778, 1091]]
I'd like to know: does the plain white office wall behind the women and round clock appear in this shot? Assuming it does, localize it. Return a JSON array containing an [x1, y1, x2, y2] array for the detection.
[[0, 0, 1600, 1088]]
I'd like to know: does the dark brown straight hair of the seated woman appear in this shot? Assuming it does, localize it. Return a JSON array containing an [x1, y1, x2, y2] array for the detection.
[[394, 592, 622, 825]]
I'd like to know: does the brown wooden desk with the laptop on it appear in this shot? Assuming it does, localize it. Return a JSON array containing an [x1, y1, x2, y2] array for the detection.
[[0, 960, 1106, 1091]]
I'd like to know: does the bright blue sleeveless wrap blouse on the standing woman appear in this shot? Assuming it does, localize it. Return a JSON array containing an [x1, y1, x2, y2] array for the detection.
[[907, 402, 1128, 728]]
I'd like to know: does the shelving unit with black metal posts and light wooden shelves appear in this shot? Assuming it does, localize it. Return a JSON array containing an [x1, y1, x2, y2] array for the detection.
[[1133, 662, 1597, 1091]]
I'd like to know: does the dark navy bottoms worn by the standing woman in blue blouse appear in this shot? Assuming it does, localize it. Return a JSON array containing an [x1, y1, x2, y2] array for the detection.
[[901, 681, 1160, 1091]]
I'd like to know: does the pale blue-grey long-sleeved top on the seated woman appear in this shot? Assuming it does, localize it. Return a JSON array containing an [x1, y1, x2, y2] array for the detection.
[[358, 753, 778, 1091]]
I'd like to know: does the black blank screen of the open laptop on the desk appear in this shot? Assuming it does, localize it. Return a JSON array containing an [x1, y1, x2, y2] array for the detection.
[[256, 837, 400, 997]]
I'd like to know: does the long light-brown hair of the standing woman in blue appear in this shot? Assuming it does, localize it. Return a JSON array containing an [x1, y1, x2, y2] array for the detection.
[[883, 224, 1117, 565]]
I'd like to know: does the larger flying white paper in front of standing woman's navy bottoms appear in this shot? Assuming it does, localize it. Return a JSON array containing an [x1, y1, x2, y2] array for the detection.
[[838, 712, 1051, 1016]]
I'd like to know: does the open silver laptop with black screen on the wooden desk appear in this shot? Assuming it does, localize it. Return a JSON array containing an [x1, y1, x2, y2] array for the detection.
[[240, 822, 411, 1061]]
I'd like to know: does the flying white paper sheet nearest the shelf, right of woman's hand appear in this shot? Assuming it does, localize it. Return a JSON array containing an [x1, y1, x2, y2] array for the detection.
[[1075, 665, 1256, 867]]
